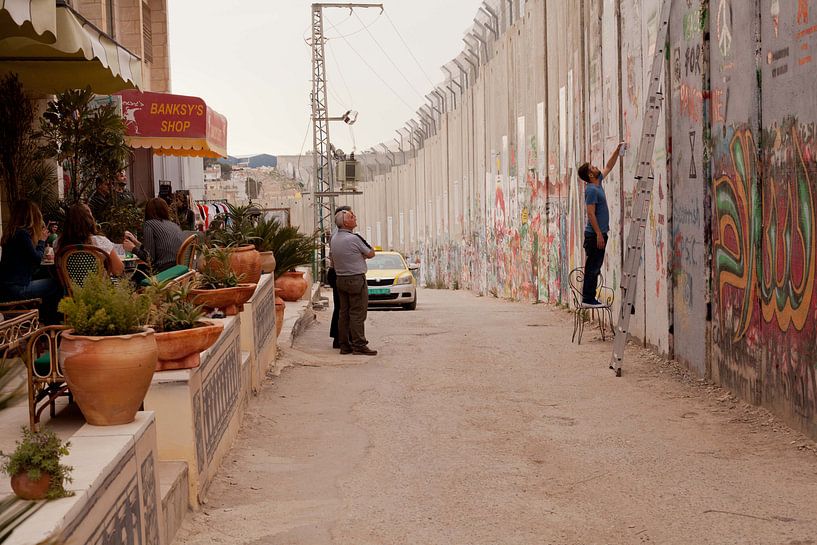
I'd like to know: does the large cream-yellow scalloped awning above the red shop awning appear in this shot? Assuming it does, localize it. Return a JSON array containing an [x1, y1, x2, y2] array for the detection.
[[0, 5, 142, 94]]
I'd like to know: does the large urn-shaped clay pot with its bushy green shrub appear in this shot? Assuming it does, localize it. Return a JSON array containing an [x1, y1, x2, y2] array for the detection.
[[59, 273, 158, 426]]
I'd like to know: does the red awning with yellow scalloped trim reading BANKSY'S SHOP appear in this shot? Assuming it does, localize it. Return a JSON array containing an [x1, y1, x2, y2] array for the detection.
[[117, 91, 227, 157]]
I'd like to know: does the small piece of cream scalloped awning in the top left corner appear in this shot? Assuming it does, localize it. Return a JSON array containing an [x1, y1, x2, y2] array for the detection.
[[0, 0, 57, 44]]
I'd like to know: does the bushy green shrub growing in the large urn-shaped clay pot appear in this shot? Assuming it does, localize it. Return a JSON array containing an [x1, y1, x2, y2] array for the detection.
[[59, 273, 150, 336]]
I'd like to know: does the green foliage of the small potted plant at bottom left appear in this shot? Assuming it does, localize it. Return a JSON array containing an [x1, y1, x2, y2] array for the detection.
[[0, 426, 74, 500]]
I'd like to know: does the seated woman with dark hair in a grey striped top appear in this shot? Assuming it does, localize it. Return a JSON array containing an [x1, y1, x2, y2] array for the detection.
[[122, 197, 187, 274]]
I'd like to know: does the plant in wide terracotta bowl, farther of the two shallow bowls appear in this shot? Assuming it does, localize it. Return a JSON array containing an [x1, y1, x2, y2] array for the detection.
[[190, 246, 256, 316]]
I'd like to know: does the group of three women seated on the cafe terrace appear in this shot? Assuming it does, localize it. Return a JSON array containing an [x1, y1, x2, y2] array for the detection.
[[0, 197, 186, 324]]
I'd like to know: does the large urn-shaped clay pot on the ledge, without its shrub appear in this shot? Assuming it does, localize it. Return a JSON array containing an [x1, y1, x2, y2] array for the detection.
[[60, 328, 159, 426]]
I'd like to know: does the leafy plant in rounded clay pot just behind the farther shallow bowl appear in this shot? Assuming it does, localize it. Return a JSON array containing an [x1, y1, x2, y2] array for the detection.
[[207, 203, 261, 284]]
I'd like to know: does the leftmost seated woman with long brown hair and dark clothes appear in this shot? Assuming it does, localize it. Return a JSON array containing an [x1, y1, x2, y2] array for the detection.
[[0, 201, 63, 324]]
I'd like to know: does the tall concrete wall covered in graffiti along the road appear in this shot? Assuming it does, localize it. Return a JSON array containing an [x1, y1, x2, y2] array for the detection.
[[334, 0, 817, 437]]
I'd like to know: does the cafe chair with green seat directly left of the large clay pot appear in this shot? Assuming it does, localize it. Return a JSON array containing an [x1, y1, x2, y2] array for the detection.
[[23, 326, 73, 431]]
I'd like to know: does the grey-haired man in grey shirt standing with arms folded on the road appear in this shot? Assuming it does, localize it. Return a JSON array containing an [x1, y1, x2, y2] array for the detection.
[[329, 206, 377, 356]]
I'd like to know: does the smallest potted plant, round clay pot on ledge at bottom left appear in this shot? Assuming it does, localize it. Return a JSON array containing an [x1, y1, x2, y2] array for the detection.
[[0, 426, 73, 500]]
